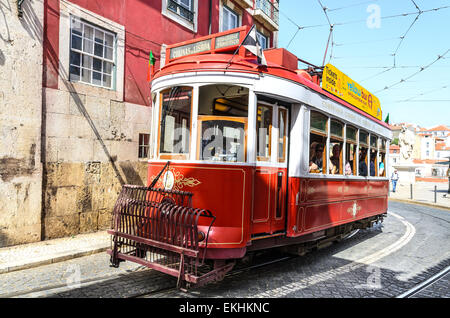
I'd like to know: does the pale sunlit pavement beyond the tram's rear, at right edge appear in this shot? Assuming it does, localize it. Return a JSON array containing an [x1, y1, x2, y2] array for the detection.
[[389, 182, 450, 209]]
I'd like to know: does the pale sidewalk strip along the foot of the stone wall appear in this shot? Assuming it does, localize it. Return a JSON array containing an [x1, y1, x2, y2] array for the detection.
[[0, 231, 111, 274]]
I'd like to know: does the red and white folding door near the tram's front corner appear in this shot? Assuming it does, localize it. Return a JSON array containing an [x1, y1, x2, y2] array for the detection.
[[252, 103, 288, 235]]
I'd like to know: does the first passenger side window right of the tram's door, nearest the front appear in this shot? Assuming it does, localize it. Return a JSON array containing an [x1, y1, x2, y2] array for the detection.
[[309, 111, 328, 173]]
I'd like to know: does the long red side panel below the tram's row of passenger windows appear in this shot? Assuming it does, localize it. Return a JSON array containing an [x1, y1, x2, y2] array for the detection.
[[287, 177, 389, 237]]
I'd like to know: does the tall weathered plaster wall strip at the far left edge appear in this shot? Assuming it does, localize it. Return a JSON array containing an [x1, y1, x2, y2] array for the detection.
[[0, 0, 44, 247]]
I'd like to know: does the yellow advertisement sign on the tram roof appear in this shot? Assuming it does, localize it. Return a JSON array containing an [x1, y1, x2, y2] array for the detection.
[[322, 64, 382, 120]]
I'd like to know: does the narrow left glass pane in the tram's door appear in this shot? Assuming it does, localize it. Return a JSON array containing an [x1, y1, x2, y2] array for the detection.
[[256, 105, 272, 161]]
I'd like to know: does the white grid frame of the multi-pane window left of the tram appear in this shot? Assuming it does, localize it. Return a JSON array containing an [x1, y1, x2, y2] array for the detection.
[[69, 16, 117, 89]]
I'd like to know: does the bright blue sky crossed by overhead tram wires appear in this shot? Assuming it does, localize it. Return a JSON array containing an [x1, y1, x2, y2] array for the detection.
[[278, 0, 450, 128]]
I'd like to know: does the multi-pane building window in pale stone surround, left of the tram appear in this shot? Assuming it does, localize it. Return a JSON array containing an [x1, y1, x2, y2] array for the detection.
[[69, 18, 116, 88]]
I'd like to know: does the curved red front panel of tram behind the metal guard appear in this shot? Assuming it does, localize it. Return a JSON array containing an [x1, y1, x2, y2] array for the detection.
[[148, 162, 254, 258]]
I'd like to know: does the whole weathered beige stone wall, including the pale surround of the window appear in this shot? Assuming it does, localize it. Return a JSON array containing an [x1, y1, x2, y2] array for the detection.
[[0, 0, 151, 247]]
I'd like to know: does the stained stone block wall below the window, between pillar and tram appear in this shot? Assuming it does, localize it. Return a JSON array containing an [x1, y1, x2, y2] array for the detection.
[[43, 84, 151, 239]]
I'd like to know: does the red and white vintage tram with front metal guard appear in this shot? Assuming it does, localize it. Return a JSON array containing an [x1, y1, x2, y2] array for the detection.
[[108, 27, 392, 286]]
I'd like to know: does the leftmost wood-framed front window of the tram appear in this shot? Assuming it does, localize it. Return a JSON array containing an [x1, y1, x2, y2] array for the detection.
[[159, 86, 192, 158]]
